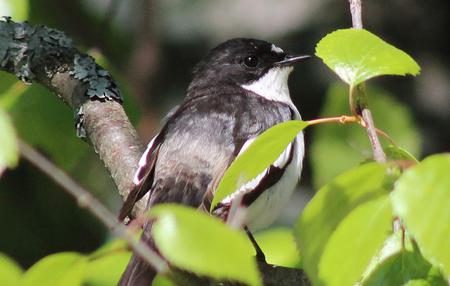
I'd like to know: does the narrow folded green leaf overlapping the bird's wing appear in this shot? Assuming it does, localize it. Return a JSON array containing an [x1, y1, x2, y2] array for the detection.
[[210, 120, 308, 211]]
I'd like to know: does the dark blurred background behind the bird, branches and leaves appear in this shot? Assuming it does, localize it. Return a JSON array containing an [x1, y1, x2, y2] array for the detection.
[[0, 0, 450, 267]]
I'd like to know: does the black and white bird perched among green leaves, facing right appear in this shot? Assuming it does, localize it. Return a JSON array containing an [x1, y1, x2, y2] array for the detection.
[[119, 38, 308, 286]]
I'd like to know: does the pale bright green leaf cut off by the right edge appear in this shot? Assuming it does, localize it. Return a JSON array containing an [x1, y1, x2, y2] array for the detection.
[[391, 154, 450, 275]]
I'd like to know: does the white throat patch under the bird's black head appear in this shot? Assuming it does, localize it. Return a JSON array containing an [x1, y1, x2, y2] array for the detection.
[[241, 67, 293, 105]]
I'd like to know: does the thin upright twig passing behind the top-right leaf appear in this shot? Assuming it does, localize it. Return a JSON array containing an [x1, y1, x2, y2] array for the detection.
[[349, 0, 386, 163]]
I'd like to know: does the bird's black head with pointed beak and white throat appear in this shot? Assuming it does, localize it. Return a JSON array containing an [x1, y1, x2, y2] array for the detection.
[[188, 38, 309, 102]]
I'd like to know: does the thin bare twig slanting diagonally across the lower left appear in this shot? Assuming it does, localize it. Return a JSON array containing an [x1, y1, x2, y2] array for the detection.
[[19, 141, 168, 273]]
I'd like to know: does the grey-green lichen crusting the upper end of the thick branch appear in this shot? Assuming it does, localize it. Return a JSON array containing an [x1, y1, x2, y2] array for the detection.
[[0, 17, 122, 102]]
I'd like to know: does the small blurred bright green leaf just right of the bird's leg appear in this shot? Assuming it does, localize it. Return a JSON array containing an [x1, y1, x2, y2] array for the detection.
[[255, 227, 300, 267]]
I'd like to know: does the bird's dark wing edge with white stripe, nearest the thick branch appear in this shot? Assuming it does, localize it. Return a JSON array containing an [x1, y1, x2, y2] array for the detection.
[[119, 133, 163, 220]]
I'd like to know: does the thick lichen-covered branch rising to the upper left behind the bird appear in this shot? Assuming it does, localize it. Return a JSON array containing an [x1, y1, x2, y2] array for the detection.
[[0, 18, 148, 213]]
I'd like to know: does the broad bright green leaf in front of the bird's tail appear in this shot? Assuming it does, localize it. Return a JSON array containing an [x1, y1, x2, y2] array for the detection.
[[150, 204, 261, 285]]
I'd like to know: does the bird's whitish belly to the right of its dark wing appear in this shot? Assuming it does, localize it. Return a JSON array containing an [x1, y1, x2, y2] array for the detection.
[[246, 134, 304, 231]]
